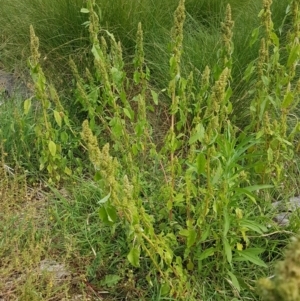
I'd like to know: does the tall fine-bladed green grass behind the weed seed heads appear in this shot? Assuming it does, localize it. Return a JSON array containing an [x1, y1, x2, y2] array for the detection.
[[0, 0, 289, 106]]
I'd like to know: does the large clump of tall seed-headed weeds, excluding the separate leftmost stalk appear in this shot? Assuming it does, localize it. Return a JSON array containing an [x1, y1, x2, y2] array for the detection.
[[74, 1, 298, 299]]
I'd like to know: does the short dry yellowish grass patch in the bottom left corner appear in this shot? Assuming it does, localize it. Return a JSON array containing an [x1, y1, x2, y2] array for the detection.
[[0, 164, 101, 301]]
